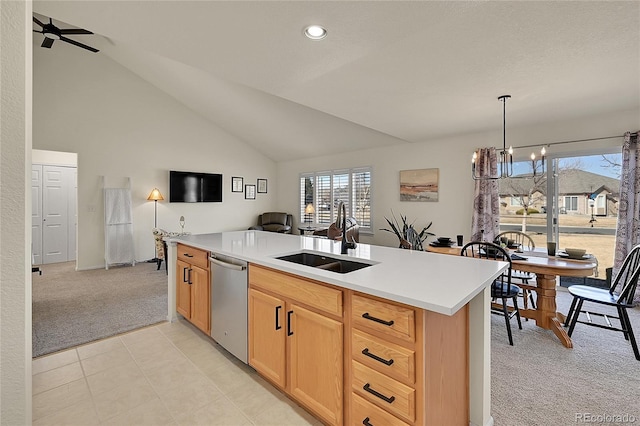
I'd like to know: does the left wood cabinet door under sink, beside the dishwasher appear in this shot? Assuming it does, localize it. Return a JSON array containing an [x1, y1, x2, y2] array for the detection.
[[249, 289, 286, 389]]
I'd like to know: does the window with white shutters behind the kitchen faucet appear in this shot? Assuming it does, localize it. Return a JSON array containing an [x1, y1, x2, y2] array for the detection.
[[300, 167, 372, 232]]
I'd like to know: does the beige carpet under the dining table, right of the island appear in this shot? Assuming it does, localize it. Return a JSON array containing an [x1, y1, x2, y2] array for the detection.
[[491, 289, 640, 426]]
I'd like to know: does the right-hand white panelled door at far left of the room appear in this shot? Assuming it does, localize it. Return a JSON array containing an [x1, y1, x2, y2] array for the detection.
[[42, 166, 69, 264]]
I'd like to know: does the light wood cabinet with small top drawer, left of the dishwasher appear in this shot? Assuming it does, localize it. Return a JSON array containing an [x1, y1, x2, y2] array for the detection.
[[176, 244, 211, 335]]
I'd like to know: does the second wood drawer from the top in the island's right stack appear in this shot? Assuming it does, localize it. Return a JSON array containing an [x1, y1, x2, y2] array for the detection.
[[351, 329, 415, 384]]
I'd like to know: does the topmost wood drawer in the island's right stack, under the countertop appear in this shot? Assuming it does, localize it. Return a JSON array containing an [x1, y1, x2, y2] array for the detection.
[[351, 294, 416, 342]]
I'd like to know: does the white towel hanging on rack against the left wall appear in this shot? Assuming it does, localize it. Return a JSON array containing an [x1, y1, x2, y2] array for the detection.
[[104, 188, 135, 269]]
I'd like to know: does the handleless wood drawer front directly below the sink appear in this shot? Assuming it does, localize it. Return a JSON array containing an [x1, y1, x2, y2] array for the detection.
[[249, 264, 342, 317]]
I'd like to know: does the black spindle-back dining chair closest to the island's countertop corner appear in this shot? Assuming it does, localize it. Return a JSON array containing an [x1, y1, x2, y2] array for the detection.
[[460, 241, 522, 346]]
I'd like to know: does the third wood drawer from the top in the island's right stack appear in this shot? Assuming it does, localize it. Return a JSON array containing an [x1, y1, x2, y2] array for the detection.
[[351, 361, 416, 423]]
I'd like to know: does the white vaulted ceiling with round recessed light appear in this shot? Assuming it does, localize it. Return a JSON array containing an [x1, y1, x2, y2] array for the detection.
[[33, 0, 640, 161]]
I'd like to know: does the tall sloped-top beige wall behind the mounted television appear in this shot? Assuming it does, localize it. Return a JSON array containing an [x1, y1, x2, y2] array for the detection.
[[33, 43, 278, 269]]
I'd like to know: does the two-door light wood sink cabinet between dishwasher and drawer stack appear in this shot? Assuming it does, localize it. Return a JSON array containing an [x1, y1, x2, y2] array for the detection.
[[249, 264, 344, 425]]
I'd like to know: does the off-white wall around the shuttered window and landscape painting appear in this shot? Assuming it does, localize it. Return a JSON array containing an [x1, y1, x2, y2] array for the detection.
[[278, 110, 640, 250]]
